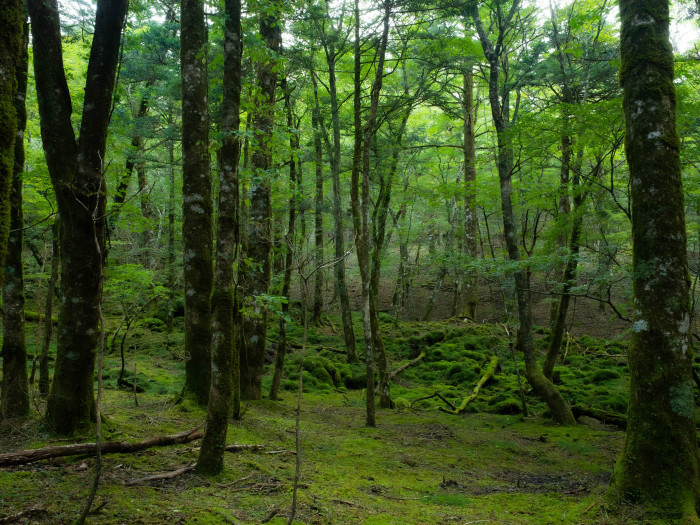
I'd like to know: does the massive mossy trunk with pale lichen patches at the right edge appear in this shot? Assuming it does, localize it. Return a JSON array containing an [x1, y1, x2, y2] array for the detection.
[[612, 0, 700, 512]]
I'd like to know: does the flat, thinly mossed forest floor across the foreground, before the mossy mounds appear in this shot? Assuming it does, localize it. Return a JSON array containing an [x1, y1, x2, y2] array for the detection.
[[0, 390, 632, 524]]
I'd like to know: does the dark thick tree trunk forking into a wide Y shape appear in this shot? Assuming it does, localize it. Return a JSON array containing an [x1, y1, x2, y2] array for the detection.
[[29, 0, 128, 434]]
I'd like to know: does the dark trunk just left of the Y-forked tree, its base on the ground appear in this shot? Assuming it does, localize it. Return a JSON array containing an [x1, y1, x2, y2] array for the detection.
[[0, 19, 28, 419]]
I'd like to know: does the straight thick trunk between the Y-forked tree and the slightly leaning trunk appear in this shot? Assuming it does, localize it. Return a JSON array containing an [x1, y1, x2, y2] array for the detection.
[[180, 0, 213, 405]]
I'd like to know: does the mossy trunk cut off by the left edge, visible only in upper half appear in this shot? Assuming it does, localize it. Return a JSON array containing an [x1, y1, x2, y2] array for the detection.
[[0, 0, 26, 278]]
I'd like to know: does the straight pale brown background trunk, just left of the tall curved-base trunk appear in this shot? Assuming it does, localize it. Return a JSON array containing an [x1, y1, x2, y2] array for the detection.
[[461, 70, 479, 320]]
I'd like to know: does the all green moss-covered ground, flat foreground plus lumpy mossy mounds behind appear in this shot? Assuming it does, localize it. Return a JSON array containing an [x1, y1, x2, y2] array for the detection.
[[0, 316, 652, 524]]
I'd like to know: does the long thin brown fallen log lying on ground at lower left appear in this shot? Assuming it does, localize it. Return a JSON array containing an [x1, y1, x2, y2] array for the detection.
[[0, 427, 204, 467]]
